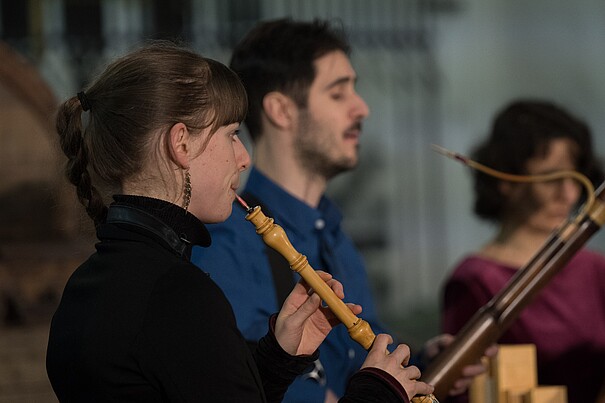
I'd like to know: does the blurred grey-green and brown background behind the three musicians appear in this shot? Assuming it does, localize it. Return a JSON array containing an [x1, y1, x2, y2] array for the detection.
[[0, 0, 605, 402]]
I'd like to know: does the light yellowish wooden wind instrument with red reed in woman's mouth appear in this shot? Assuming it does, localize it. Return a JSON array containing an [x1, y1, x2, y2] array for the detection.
[[237, 196, 438, 403]]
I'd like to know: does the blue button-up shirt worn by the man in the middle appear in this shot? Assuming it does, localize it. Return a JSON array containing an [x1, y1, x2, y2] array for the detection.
[[192, 168, 384, 402]]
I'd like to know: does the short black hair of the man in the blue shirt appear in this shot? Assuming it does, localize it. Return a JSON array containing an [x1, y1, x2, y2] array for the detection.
[[230, 18, 350, 140]]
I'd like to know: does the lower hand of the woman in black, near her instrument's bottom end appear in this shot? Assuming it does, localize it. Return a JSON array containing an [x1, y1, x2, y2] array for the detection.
[[361, 334, 434, 399]]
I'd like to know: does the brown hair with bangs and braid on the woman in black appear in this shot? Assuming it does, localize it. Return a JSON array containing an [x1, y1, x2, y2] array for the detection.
[[57, 42, 247, 225]]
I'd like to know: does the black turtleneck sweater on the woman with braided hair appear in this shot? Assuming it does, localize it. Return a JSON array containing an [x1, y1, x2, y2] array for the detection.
[[46, 196, 317, 403]]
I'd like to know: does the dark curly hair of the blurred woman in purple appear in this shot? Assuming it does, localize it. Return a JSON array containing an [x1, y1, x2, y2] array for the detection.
[[471, 99, 604, 222]]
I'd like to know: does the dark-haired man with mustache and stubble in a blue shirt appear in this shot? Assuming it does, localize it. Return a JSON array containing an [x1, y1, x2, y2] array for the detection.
[[193, 19, 482, 402]]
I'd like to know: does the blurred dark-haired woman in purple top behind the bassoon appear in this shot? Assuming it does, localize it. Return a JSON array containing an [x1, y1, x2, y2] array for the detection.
[[443, 100, 605, 403]]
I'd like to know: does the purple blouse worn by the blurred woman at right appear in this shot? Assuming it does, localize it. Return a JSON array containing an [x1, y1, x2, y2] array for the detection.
[[442, 250, 605, 403]]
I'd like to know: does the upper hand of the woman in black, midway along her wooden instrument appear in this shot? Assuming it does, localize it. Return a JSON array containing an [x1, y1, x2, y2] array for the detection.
[[275, 270, 361, 355]]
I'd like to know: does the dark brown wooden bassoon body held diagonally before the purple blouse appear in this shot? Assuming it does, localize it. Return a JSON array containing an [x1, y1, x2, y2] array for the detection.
[[421, 183, 605, 399]]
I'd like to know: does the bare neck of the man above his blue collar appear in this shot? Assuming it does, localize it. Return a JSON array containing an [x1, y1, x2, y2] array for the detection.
[[254, 140, 327, 208]]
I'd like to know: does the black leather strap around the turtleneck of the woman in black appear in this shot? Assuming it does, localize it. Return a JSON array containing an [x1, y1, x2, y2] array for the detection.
[[106, 205, 189, 256]]
